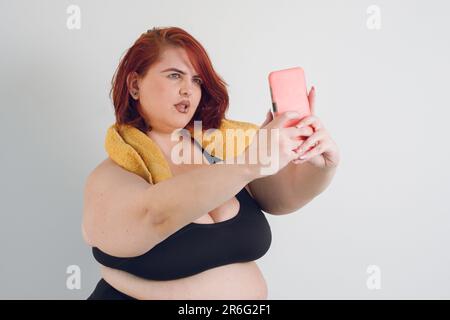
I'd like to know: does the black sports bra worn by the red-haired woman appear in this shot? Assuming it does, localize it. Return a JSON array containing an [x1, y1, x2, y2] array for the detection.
[[92, 137, 272, 280]]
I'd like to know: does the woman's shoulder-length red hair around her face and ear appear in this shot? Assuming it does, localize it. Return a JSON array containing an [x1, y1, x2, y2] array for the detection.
[[110, 27, 229, 133]]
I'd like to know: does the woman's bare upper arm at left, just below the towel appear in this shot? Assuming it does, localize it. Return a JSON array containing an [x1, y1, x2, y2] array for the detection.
[[83, 160, 161, 257]]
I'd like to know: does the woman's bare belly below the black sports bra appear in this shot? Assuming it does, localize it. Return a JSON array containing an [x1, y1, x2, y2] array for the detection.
[[101, 261, 267, 300]]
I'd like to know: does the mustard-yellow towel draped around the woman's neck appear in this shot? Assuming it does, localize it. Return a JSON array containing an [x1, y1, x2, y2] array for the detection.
[[105, 119, 259, 184]]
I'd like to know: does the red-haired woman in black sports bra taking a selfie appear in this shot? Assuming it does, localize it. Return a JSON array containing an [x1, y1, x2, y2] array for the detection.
[[82, 28, 337, 299]]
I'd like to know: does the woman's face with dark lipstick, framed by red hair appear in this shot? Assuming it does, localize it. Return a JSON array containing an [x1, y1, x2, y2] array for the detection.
[[133, 47, 202, 133]]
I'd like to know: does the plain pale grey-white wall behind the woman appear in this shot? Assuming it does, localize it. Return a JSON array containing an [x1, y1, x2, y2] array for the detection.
[[0, 0, 450, 299]]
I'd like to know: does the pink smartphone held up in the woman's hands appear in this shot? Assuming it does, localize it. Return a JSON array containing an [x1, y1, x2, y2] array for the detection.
[[269, 67, 311, 127]]
